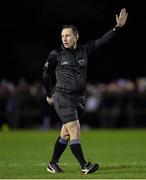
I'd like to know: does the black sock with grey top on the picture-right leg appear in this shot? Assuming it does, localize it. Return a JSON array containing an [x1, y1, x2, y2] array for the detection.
[[70, 139, 86, 168]]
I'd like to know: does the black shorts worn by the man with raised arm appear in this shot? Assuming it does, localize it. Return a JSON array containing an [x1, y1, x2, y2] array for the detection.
[[54, 92, 85, 124]]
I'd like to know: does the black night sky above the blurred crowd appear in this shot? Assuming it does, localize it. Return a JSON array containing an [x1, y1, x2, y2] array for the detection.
[[0, 0, 146, 81]]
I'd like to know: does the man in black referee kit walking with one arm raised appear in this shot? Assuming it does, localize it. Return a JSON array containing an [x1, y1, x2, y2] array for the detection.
[[43, 8, 128, 174]]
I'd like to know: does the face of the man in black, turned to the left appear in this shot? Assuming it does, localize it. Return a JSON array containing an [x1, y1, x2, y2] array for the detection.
[[61, 28, 78, 48]]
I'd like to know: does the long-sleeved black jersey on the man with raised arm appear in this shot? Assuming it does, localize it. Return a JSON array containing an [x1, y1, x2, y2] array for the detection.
[[43, 28, 116, 97]]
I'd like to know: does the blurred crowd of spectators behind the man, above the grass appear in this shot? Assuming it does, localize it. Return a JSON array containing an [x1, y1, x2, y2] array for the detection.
[[0, 77, 146, 129]]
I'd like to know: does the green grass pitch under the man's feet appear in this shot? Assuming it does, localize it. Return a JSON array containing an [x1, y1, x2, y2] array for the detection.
[[0, 129, 146, 179]]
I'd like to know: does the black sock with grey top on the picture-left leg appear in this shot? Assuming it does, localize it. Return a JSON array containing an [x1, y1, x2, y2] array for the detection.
[[50, 137, 68, 163]]
